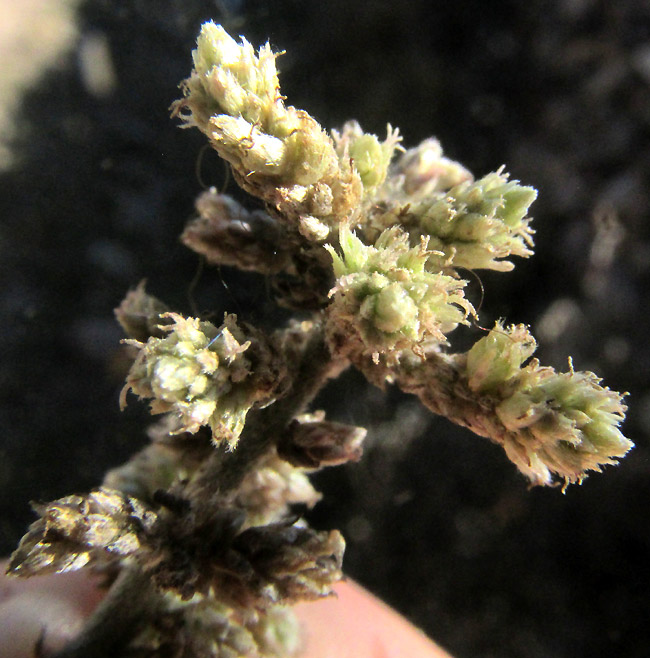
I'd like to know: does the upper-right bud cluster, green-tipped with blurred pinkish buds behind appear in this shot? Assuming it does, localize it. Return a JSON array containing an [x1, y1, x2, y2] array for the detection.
[[369, 167, 537, 272]]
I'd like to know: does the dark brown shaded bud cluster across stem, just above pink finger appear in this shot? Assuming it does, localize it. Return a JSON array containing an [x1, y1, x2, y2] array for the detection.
[[138, 500, 345, 610]]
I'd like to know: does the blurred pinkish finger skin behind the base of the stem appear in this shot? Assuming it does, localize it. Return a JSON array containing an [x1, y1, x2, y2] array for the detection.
[[0, 565, 451, 658]]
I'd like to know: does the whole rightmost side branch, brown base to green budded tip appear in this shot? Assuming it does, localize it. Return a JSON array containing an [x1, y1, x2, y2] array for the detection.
[[386, 324, 632, 486]]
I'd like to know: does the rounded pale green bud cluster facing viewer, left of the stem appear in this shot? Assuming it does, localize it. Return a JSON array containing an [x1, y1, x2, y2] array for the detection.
[[121, 313, 272, 447]]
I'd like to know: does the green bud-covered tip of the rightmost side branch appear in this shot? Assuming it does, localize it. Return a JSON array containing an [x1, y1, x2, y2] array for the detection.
[[467, 324, 633, 484]]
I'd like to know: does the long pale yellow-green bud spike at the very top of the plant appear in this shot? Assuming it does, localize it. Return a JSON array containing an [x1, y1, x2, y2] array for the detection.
[[173, 22, 363, 242]]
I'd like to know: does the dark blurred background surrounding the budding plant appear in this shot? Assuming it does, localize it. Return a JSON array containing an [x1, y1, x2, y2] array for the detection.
[[0, 0, 650, 658]]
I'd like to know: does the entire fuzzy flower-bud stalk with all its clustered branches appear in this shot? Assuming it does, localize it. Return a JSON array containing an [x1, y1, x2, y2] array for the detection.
[[10, 23, 632, 658]]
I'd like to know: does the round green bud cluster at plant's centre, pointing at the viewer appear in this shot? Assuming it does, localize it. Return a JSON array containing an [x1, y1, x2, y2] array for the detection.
[[326, 226, 474, 361]]
